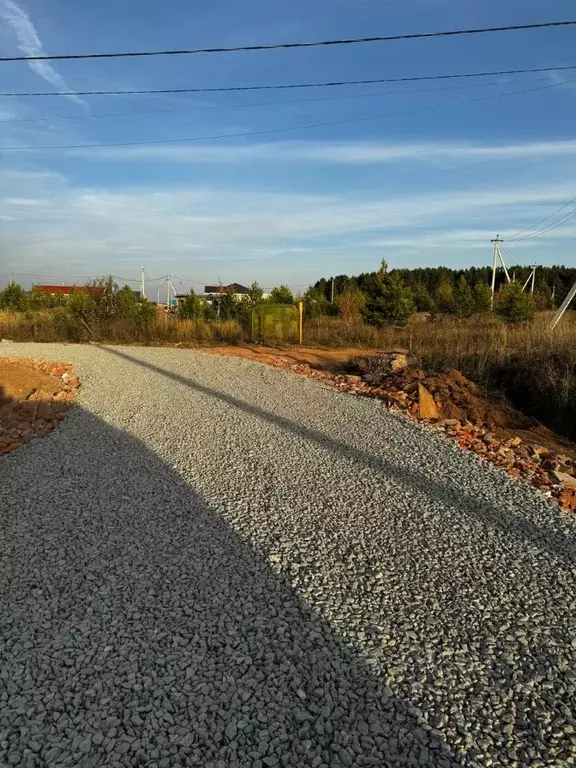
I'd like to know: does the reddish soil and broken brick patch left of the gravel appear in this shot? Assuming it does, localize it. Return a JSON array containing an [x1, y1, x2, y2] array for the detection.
[[0, 357, 80, 456]]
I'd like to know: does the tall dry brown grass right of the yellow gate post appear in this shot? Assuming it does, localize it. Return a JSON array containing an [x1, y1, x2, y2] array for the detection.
[[305, 312, 576, 439]]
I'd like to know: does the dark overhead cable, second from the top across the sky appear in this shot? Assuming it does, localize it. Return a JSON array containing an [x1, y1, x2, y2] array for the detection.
[[0, 64, 576, 98]]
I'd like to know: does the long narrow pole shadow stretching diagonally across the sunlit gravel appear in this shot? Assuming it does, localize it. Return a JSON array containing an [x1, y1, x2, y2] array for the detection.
[[100, 347, 576, 566]]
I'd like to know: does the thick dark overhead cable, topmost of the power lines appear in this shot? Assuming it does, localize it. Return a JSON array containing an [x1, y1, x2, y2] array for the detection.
[[0, 20, 576, 61]]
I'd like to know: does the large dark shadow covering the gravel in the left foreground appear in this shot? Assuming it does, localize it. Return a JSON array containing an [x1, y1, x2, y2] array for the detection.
[[0, 404, 461, 768]]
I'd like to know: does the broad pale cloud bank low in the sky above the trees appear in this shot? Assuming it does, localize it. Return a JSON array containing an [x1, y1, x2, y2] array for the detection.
[[0, 171, 574, 284]]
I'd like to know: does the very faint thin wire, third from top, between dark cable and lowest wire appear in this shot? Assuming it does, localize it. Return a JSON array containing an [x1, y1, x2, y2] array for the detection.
[[0, 77, 548, 125]]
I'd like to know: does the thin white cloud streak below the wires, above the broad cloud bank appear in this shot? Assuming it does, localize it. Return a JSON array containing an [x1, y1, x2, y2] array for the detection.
[[88, 140, 576, 165]]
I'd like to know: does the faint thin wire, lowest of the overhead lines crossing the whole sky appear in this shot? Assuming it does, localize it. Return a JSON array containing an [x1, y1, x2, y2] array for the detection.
[[0, 80, 572, 152]]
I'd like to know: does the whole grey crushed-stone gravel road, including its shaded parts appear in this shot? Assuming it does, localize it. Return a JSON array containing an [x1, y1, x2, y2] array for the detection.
[[0, 344, 576, 768]]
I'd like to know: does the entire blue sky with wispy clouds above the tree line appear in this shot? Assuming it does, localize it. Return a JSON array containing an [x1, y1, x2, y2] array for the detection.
[[0, 0, 576, 296]]
